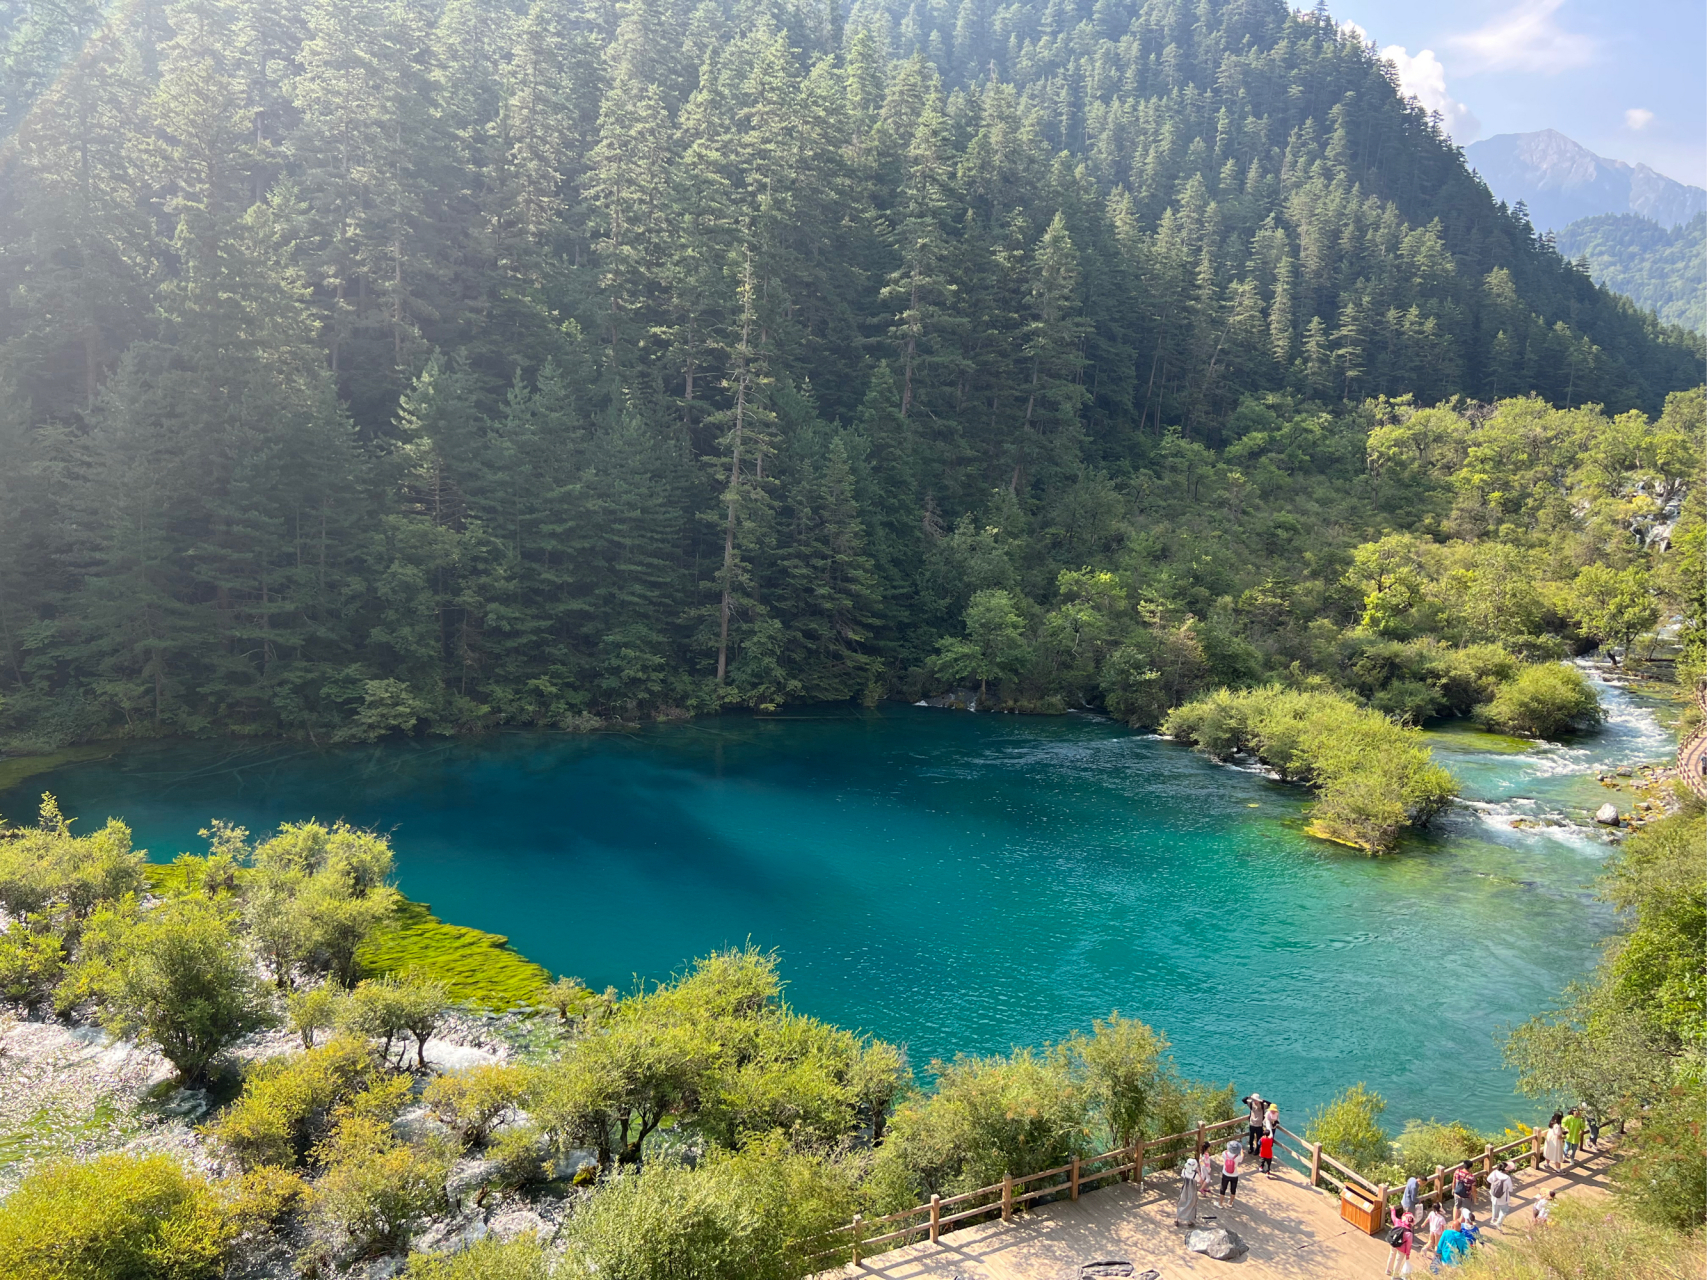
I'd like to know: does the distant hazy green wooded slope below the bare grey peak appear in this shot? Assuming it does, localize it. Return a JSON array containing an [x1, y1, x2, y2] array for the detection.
[[1558, 213, 1707, 333]]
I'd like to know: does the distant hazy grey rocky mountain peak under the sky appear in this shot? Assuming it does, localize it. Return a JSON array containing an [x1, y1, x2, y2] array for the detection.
[[1465, 130, 1707, 232]]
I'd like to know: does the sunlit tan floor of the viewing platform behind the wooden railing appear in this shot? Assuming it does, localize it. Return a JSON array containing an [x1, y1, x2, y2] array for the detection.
[[824, 1152, 1611, 1280]]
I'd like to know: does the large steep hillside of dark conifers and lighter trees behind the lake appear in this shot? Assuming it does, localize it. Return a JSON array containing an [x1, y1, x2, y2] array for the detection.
[[0, 0, 1702, 746]]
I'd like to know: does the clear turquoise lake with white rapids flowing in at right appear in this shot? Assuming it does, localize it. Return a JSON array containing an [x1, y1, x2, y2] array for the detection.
[[0, 672, 1673, 1125]]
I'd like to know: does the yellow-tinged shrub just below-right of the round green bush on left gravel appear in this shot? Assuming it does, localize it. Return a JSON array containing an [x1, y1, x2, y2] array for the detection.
[[208, 1038, 374, 1169]]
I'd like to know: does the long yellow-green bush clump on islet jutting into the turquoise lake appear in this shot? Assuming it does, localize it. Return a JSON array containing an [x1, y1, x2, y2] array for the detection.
[[1162, 686, 1458, 852]]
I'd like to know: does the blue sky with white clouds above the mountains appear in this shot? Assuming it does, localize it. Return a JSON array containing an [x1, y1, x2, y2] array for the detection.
[[1331, 0, 1707, 186]]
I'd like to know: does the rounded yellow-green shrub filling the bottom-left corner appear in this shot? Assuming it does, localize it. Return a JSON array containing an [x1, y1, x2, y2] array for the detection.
[[0, 1155, 239, 1280]]
